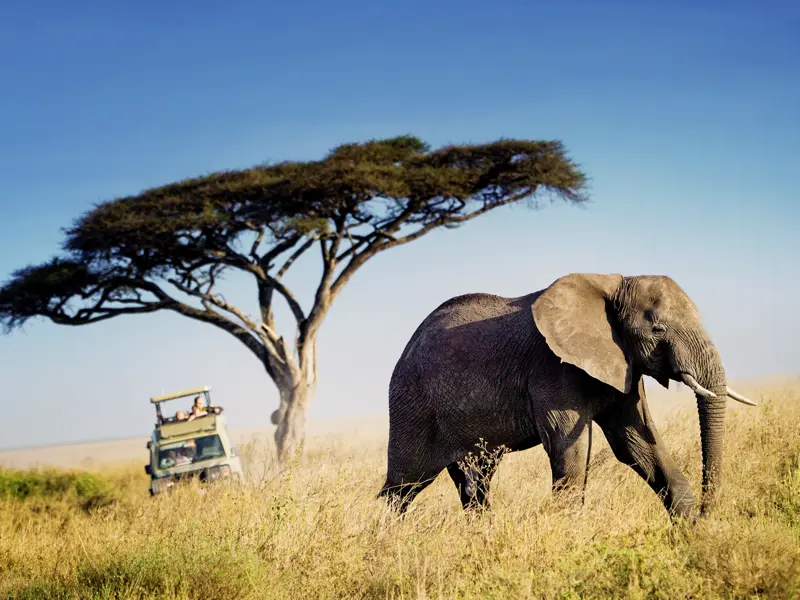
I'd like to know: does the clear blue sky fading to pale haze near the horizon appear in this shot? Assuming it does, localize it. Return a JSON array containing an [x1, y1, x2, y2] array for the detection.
[[0, 1, 800, 447]]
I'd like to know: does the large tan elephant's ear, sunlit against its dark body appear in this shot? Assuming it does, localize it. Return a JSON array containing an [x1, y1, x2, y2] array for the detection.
[[533, 273, 633, 394]]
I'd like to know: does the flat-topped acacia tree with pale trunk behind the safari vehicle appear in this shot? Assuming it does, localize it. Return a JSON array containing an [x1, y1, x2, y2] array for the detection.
[[0, 136, 586, 460]]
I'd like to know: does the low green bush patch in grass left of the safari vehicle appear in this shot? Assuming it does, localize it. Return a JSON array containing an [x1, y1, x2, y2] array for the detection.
[[0, 468, 117, 511]]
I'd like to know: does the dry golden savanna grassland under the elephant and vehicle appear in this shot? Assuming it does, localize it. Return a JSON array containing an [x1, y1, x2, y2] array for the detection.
[[0, 383, 800, 600]]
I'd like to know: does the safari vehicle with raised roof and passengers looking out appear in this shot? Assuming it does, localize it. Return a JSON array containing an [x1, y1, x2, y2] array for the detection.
[[144, 386, 242, 496]]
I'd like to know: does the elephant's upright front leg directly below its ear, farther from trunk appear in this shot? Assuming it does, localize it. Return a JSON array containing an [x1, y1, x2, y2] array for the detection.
[[537, 410, 592, 505]]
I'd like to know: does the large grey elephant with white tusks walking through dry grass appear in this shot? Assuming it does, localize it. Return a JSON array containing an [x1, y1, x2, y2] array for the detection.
[[378, 273, 756, 519]]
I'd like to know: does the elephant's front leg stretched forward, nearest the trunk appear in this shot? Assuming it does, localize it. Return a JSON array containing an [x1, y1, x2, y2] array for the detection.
[[595, 382, 694, 517]]
